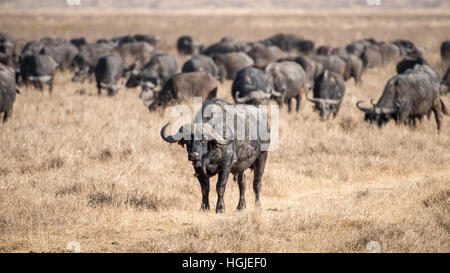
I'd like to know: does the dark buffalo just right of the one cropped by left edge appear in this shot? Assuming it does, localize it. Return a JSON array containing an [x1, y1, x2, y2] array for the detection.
[[19, 54, 58, 93]]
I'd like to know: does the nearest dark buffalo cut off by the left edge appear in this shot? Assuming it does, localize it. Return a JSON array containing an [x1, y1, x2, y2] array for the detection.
[[0, 64, 19, 122]]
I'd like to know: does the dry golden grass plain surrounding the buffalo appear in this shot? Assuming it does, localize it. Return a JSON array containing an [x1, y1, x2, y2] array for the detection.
[[0, 7, 450, 252]]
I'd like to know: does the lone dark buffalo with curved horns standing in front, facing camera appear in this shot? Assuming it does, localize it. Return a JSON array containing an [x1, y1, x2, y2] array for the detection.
[[161, 99, 270, 213]]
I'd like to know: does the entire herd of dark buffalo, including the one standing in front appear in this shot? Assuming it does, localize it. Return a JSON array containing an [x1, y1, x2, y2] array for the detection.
[[0, 30, 450, 212]]
